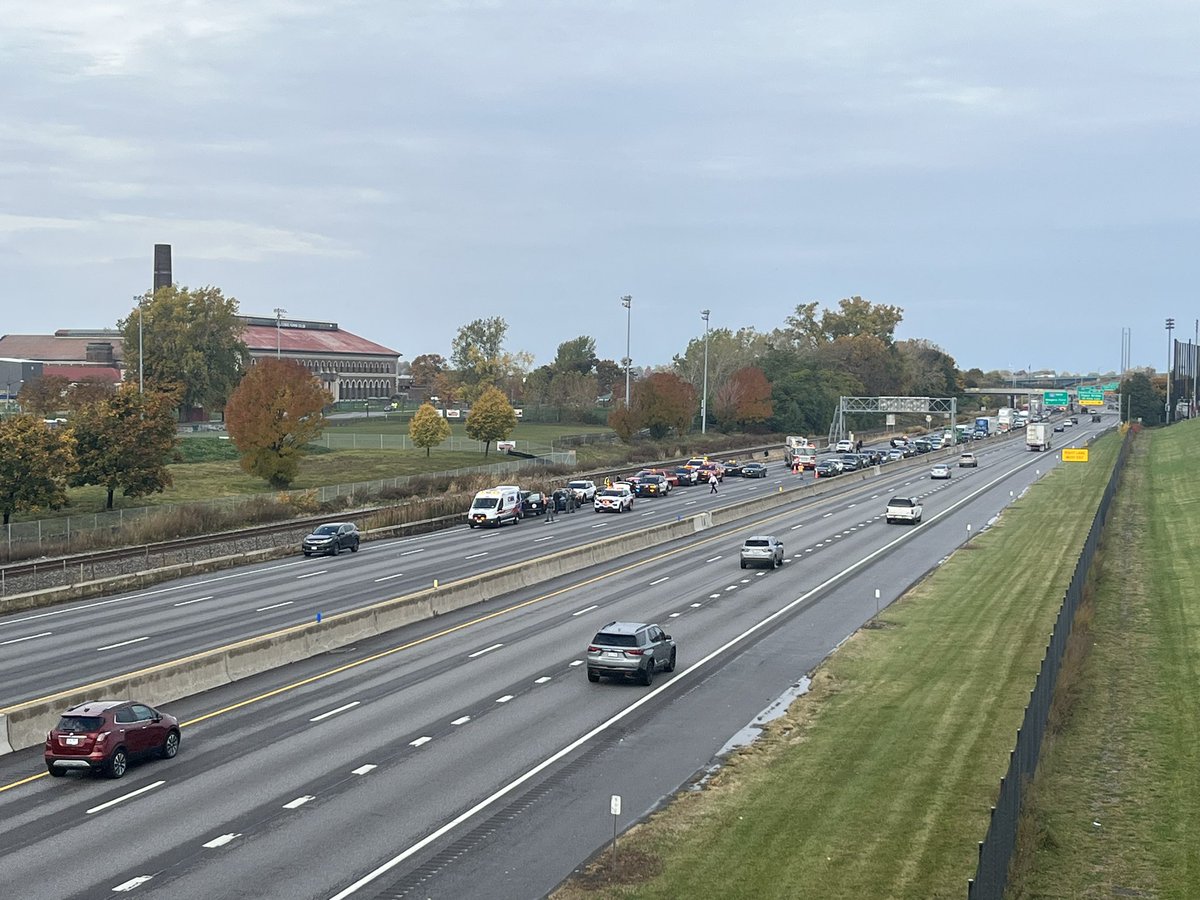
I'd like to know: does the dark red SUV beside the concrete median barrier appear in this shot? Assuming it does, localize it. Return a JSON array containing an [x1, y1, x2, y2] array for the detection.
[[46, 700, 179, 778]]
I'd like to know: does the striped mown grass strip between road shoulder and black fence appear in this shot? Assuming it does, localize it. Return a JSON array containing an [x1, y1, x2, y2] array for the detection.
[[553, 434, 1121, 900]]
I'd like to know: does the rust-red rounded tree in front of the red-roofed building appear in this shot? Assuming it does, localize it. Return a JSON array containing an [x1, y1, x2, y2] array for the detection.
[[226, 358, 332, 488]]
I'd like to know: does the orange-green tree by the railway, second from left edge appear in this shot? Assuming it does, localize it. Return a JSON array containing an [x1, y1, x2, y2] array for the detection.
[[68, 383, 179, 509]]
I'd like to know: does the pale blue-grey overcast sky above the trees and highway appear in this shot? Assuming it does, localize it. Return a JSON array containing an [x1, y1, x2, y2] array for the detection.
[[0, 0, 1200, 372]]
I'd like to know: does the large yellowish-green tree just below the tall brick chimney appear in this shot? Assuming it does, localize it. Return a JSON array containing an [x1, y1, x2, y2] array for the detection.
[[118, 286, 248, 410]]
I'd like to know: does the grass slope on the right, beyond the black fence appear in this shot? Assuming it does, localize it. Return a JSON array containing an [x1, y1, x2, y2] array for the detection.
[[1009, 422, 1200, 898]]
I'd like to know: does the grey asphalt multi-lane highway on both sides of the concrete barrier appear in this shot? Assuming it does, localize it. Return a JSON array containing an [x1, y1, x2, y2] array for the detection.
[[0, 425, 1103, 900]]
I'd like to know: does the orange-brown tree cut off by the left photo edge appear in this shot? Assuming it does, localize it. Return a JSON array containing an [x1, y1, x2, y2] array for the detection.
[[0, 414, 74, 524]]
